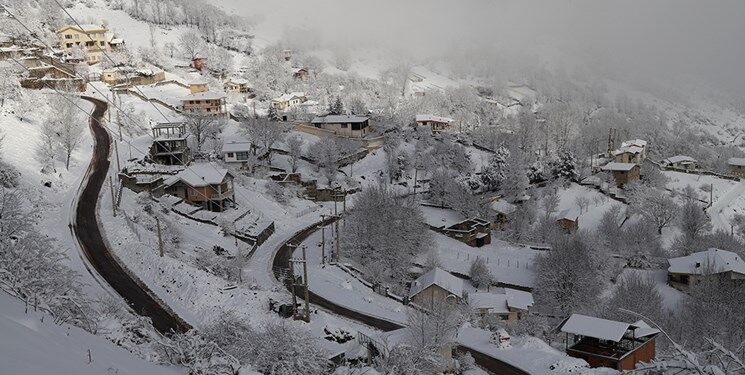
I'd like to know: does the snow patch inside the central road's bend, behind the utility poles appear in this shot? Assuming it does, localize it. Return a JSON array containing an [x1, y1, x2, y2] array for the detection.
[[294, 224, 408, 325]]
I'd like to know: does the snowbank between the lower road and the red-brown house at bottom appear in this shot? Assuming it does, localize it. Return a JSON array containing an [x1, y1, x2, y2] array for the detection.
[[457, 326, 618, 375]]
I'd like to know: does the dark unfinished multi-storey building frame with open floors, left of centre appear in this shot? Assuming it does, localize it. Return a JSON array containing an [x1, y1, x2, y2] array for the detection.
[[150, 122, 191, 165]]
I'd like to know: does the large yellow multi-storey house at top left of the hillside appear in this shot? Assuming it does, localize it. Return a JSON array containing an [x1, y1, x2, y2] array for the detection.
[[57, 24, 111, 65]]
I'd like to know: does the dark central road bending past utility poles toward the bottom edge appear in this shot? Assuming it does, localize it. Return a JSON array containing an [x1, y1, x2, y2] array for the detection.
[[272, 218, 528, 375]]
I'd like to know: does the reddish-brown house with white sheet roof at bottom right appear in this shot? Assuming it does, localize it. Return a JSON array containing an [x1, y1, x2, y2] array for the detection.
[[557, 314, 660, 371]]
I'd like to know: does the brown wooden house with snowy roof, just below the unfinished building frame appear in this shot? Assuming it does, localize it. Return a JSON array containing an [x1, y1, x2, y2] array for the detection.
[[163, 163, 235, 212]]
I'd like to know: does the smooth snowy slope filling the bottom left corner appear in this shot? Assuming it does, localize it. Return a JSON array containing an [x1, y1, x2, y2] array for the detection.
[[0, 292, 185, 375]]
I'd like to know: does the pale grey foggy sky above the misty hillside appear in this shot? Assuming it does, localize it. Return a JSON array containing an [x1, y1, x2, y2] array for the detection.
[[219, 0, 745, 92]]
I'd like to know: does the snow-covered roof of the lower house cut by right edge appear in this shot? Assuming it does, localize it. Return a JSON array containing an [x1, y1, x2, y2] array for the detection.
[[667, 248, 745, 275]]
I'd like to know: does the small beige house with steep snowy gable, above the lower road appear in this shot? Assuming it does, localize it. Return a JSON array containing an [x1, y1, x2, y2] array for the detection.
[[409, 267, 463, 308]]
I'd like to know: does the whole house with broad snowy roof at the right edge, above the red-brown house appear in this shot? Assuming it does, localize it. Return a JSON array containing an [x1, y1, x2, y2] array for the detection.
[[667, 248, 745, 289]]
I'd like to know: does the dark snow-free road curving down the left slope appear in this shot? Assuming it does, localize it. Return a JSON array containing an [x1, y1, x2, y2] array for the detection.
[[72, 97, 191, 333]]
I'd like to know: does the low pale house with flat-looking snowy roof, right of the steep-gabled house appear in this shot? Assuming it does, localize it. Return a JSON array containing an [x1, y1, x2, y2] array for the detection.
[[468, 288, 533, 323]]
